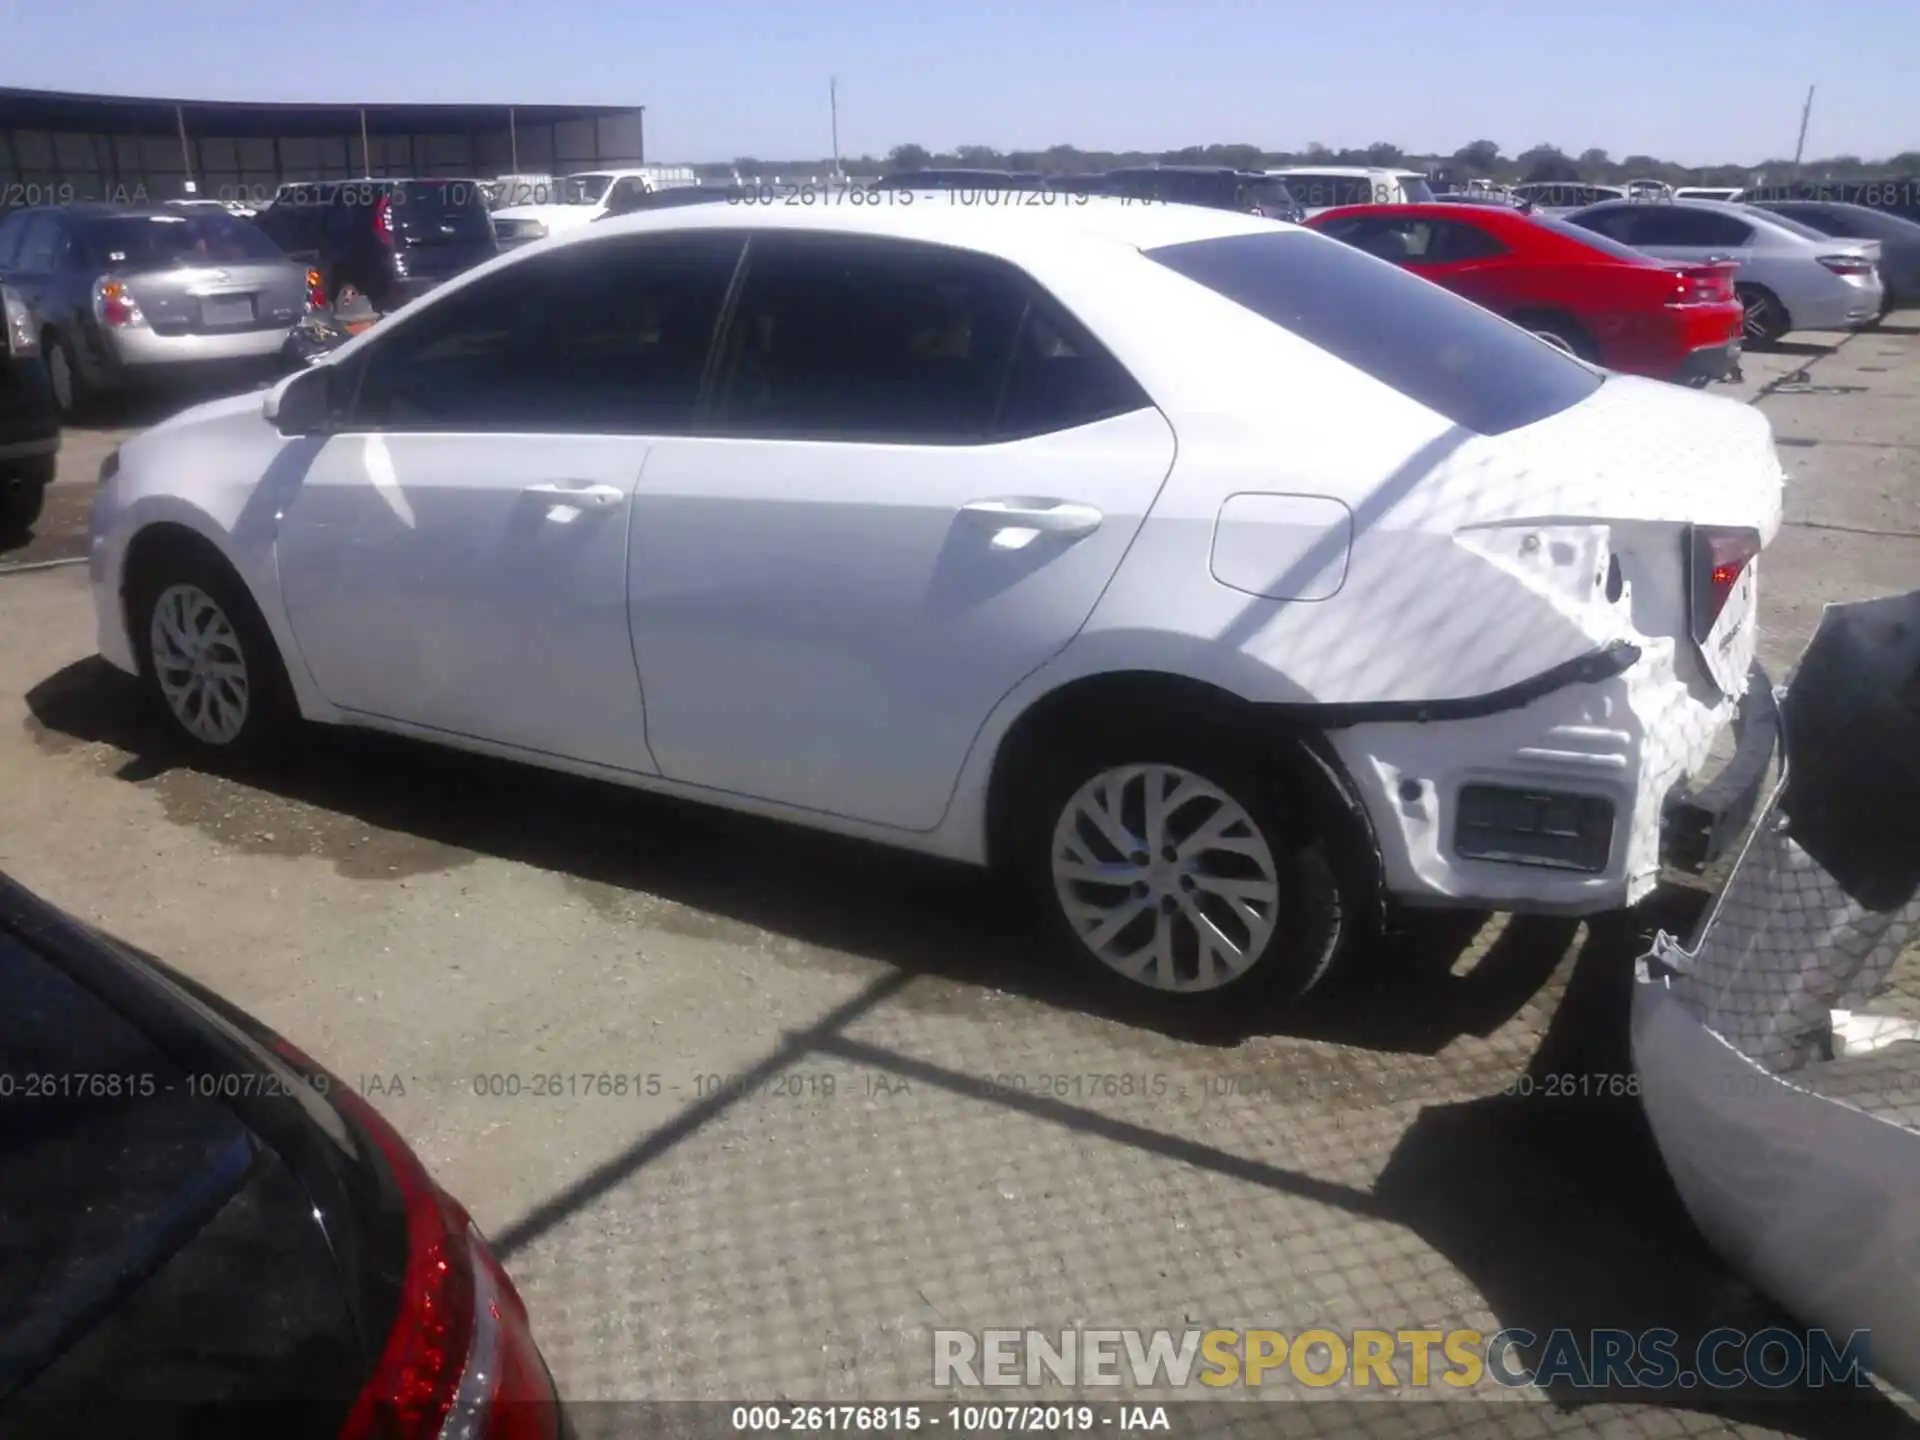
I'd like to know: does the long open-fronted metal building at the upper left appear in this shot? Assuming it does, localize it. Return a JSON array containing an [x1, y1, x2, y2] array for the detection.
[[0, 88, 647, 209]]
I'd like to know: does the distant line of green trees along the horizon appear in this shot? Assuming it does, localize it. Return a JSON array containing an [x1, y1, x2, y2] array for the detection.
[[695, 140, 1920, 184]]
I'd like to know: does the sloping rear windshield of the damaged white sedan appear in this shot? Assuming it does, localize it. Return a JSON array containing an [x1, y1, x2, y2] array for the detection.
[[1146, 230, 1601, 436]]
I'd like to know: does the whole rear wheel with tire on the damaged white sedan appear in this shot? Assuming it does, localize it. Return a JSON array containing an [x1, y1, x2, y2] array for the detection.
[[1023, 726, 1357, 1010]]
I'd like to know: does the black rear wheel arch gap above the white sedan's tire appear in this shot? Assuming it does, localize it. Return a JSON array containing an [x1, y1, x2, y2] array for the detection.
[[983, 670, 1384, 922]]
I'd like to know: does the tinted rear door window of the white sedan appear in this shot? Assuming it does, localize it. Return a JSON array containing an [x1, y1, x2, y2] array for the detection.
[[716, 236, 1146, 444]]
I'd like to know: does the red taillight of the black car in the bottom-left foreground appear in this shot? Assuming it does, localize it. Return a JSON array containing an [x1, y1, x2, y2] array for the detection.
[[322, 1075, 559, 1440]]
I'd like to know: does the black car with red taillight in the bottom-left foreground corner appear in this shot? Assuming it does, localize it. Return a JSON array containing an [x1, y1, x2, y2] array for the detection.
[[0, 876, 564, 1440]]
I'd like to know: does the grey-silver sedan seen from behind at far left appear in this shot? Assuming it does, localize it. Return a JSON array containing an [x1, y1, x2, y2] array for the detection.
[[0, 205, 317, 415]]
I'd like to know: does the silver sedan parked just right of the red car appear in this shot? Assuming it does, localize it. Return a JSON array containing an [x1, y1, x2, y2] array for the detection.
[[1565, 200, 1885, 349]]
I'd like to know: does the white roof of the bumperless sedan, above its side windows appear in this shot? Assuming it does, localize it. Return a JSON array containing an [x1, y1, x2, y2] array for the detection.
[[576, 190, 1290, 257]]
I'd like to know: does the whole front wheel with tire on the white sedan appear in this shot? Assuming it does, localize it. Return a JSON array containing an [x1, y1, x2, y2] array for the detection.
[[129, 553, 298, 758]]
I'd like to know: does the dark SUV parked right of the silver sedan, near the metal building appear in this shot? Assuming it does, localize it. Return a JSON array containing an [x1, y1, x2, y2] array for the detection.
[[319, 180, 499, 315]]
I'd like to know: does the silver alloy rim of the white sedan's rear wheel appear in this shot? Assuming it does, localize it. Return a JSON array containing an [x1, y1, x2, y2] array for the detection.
[[1050, 764, 1281, 993]]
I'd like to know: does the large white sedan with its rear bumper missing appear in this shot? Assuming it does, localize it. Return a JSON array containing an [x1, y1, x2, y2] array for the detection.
[[90, 192, 1782, 1002]]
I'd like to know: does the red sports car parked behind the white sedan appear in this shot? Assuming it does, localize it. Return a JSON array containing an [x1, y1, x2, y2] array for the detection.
[[1308, 204, 1741, 386]]
